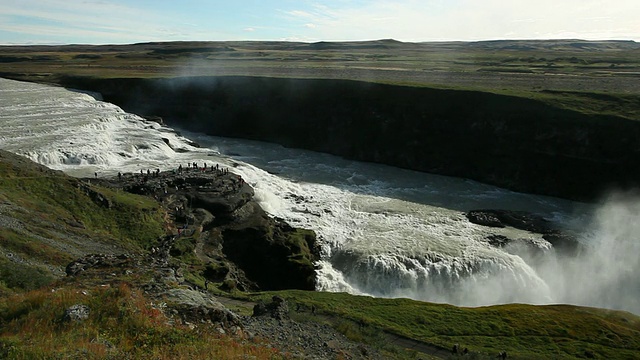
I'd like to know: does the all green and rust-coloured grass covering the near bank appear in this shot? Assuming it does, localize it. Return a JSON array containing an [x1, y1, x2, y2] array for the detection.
[[0, 152, 640, 359]]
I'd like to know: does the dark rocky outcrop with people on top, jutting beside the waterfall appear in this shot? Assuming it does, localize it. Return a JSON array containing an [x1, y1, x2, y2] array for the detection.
[[91, 164, 320, 290]]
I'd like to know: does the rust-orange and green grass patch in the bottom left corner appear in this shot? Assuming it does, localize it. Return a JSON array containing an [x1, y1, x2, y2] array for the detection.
[[0, 283, 283, 359]]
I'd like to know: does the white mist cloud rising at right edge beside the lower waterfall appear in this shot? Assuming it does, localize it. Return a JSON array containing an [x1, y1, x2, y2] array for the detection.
[[538, 192, 640, 314]]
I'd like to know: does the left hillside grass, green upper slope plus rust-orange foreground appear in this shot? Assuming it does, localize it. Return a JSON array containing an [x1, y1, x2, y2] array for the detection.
[[0, 151, 282, 359]]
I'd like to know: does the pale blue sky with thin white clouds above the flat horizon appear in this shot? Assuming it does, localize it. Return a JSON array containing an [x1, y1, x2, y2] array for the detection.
[[0, 0, 640, 44]]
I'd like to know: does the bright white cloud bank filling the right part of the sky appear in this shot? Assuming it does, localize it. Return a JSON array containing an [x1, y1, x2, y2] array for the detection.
[[286, 0, 640, 41]]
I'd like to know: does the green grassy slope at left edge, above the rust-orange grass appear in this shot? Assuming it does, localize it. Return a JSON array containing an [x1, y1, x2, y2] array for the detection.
[[0, 152, 168, 291]]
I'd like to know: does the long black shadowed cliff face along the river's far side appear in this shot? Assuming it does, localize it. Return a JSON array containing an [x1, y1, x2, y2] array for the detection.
[[63, 77, 640, 200]]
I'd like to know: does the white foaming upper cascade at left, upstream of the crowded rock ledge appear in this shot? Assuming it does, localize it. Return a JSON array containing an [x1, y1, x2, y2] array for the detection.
[[0, 79, 221, 176]]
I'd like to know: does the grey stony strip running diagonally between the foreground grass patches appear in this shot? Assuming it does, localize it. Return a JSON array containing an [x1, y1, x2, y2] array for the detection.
[[65, 245, 386, 359]]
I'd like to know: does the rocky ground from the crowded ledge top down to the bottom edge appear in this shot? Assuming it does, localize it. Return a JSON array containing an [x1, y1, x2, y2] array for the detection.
[[58, 164, 385, 359]]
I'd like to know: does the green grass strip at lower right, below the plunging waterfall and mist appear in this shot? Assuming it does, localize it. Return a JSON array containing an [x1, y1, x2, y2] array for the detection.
[[254, 291, 640, 359]]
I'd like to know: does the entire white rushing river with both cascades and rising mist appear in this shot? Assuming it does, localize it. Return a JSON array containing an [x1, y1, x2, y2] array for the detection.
[[0, 79, 640, 313]]
